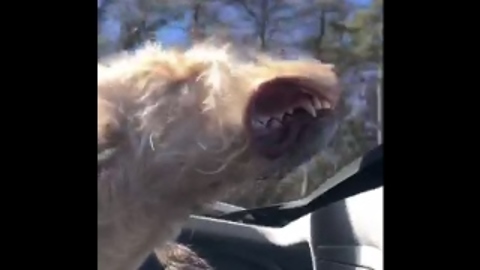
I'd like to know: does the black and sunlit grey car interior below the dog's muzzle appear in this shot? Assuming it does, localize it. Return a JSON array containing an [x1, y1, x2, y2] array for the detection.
[[141, 145, 383, 270]]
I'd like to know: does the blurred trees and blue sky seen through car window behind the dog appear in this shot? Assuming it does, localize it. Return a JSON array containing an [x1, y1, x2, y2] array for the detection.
[[97, 0, 383, 211]]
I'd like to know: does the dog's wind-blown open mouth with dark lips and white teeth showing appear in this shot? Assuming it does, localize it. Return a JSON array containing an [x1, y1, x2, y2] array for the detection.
[[246, 78, 335, 159]]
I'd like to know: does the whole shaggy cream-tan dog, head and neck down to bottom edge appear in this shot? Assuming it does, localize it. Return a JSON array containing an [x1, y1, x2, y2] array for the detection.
[[97, 44, 340, 270]]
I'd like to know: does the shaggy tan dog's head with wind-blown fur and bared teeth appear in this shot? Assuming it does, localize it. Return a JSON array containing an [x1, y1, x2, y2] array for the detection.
[[98, 43, 340, 206]]
